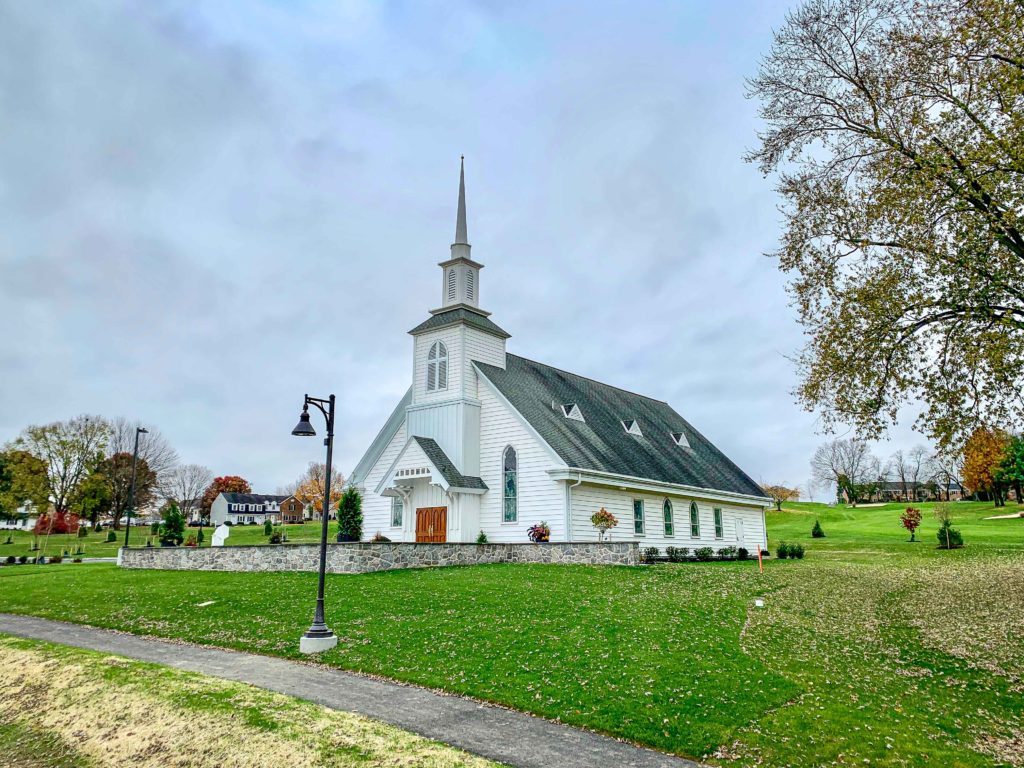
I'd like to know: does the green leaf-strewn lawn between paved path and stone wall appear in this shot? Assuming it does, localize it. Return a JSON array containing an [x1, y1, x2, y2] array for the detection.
[[0, 505, 1024, 766]]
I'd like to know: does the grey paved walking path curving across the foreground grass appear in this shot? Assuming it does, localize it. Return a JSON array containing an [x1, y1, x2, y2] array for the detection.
[[0, 613, 698, 768]]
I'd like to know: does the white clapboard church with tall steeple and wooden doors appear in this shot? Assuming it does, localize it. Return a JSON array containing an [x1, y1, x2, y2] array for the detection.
[[349, 160, 771, 552]]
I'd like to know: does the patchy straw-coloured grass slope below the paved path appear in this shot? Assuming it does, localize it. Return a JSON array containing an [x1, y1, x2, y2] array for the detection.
[[0, 635, 495, 768]]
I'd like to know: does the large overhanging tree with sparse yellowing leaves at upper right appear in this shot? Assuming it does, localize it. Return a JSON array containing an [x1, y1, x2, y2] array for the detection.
[[748, 0, 1024, 450]]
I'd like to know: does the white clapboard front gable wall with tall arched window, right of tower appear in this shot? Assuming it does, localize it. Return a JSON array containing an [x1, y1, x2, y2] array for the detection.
[[478, 381, 565, 543]]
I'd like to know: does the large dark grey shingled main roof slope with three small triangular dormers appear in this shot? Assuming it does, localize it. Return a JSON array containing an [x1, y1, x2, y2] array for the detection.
[[476, 354, 764, 497]]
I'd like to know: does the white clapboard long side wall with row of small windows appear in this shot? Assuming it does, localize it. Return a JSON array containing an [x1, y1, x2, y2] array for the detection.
[[571, 483, 764, 552]]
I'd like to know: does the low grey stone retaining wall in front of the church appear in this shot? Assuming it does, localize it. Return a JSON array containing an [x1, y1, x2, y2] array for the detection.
[[118, 542, 640, 573]]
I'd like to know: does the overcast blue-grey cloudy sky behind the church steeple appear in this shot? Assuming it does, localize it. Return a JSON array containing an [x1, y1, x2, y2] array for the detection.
[[0, 0, 921, 493]]
